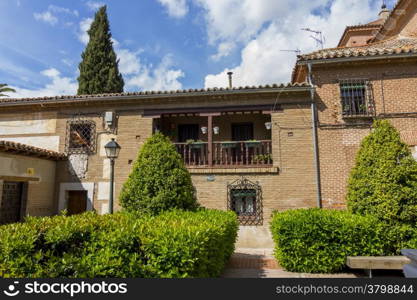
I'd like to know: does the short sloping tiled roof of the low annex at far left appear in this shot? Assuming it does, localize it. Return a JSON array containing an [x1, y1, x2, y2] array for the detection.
[[0, 141, 66, 160]]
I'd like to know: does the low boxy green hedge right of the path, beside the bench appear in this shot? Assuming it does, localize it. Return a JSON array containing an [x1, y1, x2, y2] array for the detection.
[[271, 209, 386, 273]]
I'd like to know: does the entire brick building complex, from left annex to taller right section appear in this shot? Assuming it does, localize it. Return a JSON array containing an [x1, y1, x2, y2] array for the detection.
[[0, 0, 417, 247]]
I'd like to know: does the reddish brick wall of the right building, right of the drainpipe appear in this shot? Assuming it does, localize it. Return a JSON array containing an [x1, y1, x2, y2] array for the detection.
[[313, 61, 417, 208]]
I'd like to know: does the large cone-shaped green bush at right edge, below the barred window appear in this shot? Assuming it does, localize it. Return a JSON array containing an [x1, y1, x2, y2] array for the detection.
[[347, 121, 417, 226]]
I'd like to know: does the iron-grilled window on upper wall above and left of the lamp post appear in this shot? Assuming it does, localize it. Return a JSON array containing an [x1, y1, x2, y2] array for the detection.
[[66, 120, 96, 154]]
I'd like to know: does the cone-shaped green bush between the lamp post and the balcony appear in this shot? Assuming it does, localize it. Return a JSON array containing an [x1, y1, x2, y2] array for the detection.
[[119, 133, 197, 214]]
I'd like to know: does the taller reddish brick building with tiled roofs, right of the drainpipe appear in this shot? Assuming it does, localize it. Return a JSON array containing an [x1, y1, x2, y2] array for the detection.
[[292, 0, 417, 208]]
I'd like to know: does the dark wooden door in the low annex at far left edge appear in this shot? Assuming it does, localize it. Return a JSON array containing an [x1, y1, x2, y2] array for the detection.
[[0, 181, 22, 224]]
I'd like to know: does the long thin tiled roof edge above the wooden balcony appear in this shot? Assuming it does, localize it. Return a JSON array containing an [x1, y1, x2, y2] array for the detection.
[[0, 83, 309, 105]]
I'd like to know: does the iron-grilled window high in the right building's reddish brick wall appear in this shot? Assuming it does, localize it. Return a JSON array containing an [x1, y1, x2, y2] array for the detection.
[[340, 79, 373, 117]]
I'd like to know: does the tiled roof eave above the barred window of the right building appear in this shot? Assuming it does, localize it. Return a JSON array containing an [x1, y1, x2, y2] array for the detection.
[[298, 37, 417, 62]]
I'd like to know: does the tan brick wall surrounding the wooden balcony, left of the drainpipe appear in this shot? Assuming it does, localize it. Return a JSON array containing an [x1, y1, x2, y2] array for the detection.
[[0, 94, 316, 221]]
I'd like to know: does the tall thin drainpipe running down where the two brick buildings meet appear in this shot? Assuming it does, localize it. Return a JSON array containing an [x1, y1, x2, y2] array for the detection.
[[307, 63, 323, 208]]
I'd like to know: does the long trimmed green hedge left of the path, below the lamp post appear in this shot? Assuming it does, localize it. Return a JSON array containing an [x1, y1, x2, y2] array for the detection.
[[0, 210, 238, 278]]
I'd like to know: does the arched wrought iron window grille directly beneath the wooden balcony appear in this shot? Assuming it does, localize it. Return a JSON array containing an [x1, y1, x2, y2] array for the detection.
[[227, 178, 263, 226]]
